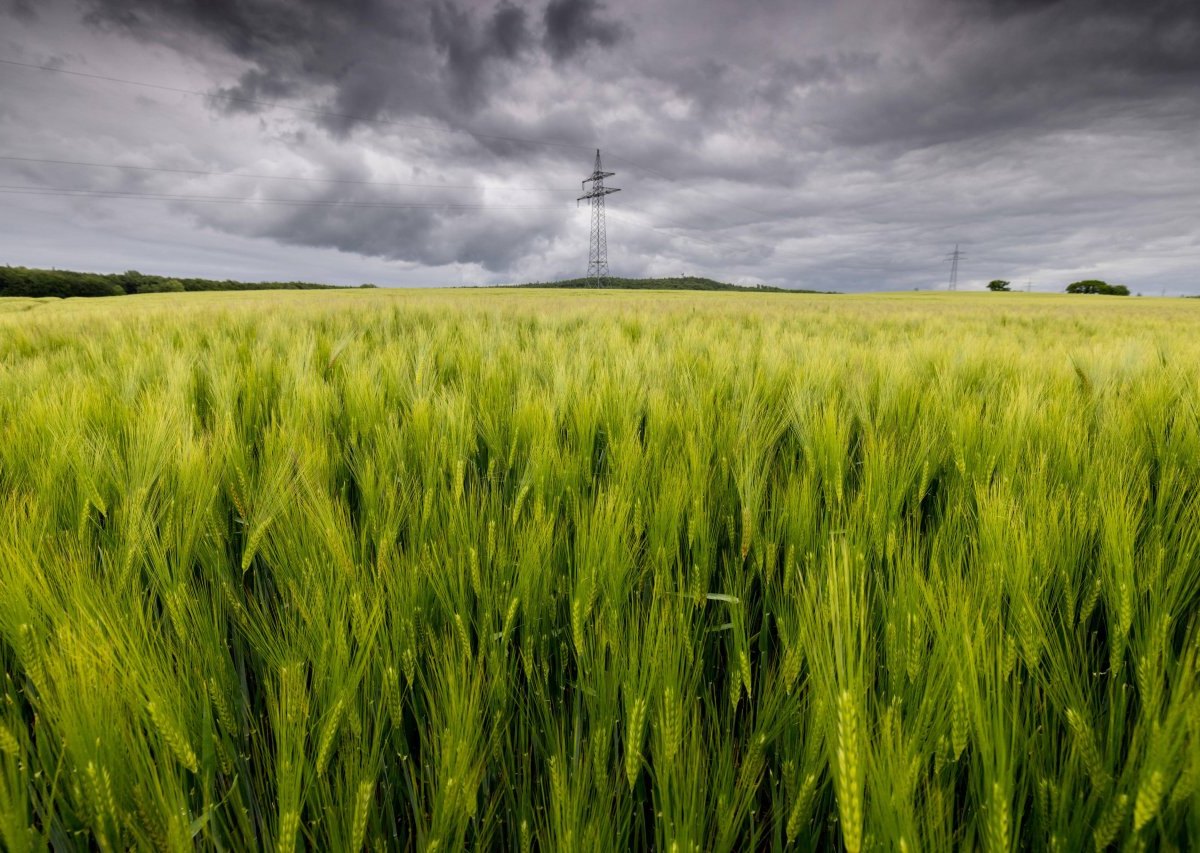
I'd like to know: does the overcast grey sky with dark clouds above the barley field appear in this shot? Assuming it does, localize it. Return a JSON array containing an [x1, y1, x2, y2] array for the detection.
[[0, 0, 1200, 295]]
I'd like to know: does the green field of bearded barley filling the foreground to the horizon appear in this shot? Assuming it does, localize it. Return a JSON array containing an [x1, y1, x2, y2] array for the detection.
[[0, 290, 1200, 853]]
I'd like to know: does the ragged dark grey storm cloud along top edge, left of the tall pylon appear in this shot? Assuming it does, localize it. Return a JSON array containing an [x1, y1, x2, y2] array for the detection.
[[82, 0, 622, 130]]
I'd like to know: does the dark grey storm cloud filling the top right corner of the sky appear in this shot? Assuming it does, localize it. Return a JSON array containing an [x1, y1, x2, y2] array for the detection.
[[806, 0, 1200, 155]]
